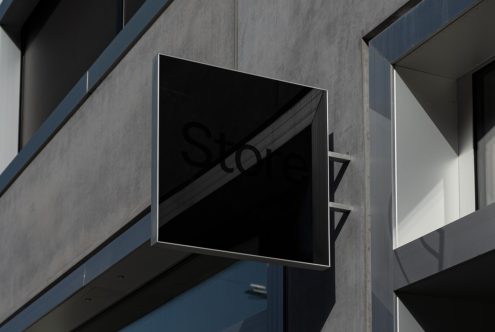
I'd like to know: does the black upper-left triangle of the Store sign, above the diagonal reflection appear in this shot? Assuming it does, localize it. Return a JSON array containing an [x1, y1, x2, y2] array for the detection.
[[160, 57, 309, 201]]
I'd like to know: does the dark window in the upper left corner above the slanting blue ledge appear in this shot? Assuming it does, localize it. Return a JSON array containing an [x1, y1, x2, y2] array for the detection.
[[20, 0, 144, 147]]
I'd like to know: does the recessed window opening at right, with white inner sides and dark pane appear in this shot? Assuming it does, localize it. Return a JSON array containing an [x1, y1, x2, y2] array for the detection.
[[394, 1, 495, 246]]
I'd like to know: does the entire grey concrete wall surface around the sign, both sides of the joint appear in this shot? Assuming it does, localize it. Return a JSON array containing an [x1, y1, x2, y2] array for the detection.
[[0, 0, 406, 331]]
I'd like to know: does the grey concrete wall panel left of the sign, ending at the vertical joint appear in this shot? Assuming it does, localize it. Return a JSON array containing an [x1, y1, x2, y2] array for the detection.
[[0, 0, 235, 322]]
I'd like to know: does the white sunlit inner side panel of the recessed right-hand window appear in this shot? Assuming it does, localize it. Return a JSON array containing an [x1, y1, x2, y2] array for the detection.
[[395, 71, 459, 246]]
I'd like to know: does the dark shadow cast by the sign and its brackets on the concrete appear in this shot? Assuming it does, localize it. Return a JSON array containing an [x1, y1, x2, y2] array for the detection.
[[285, 134, 348, 332]]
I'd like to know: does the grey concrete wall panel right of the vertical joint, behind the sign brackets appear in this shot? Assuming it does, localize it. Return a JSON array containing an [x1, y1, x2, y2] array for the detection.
[[238, 0, 407, 331]]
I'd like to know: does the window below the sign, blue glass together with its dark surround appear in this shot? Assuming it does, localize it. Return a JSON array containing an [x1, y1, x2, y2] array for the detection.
[[76, 262, 274, 332]]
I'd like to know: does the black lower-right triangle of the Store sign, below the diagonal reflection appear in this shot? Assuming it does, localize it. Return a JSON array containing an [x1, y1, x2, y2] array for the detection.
[[159, 129, 312, 261]]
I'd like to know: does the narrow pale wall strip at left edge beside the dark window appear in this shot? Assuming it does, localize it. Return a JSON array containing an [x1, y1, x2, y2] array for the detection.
[[0, 27, 21, 173]]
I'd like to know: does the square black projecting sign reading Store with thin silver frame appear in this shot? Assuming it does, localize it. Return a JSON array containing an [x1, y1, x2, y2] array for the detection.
[[152, 55, 330, 269]]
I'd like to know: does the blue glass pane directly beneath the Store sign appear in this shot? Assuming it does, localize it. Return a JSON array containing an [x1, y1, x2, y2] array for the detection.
[[122, 262, 268, 332]]
